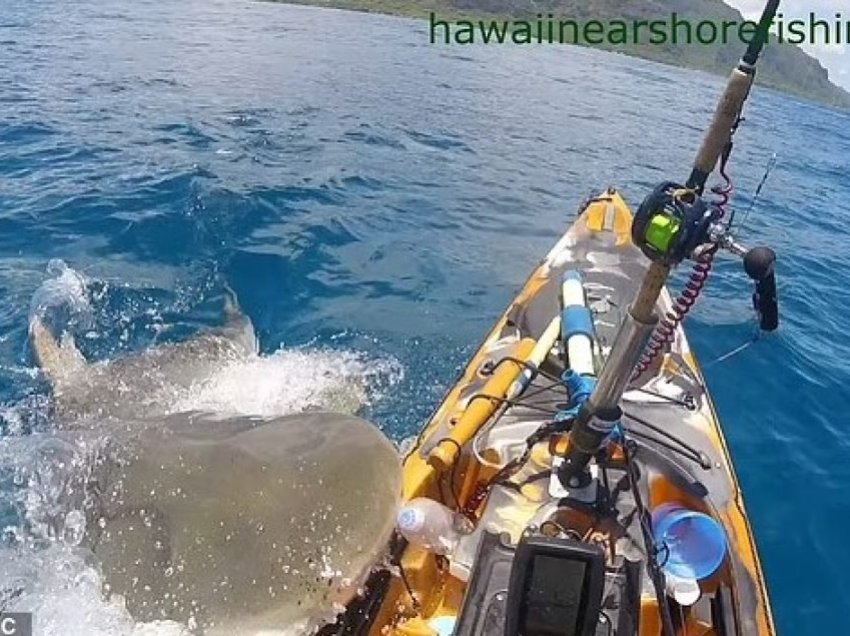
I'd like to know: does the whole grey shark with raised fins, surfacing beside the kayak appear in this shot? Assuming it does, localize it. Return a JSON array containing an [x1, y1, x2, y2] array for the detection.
[[23, 296, 401, 635]]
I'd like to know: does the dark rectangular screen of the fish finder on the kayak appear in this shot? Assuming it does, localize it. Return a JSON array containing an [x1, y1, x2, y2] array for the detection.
[[522, 554, 587, 636]]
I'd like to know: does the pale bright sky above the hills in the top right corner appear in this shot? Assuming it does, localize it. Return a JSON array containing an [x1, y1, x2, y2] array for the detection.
[[725, 0, 850, 90]]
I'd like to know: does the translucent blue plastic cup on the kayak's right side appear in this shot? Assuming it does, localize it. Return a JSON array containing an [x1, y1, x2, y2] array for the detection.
[[652, 504, 727, 581]]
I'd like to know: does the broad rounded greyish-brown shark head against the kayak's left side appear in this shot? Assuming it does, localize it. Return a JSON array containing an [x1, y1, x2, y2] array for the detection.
[[91, 413, 401, 634]]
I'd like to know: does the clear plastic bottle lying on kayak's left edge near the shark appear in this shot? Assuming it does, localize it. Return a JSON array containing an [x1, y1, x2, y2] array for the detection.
[[396, 497, 472, 554]]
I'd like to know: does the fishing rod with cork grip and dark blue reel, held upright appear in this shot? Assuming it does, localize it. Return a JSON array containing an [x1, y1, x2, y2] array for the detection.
[[557, 0, 779, 636]]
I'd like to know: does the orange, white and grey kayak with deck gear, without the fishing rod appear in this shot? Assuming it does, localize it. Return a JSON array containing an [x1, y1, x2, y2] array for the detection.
[[360, 189, 774, 636]]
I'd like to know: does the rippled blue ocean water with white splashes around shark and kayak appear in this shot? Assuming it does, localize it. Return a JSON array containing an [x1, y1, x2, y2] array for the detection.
[[0, 0, 850, 636]]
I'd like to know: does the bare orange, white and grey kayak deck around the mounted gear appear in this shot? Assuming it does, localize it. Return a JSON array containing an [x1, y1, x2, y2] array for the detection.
[[371, 190, 773, 636]]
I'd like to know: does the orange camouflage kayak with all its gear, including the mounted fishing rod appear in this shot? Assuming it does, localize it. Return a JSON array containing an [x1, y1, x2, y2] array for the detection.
[[322, 0, 779, 636]]
